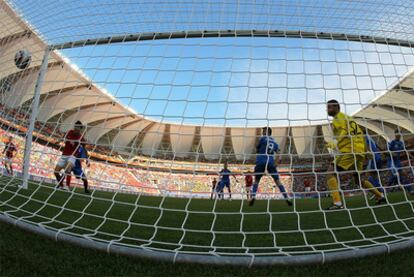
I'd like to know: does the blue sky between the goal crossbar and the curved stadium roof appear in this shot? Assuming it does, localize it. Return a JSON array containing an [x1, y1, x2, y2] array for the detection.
[[63, 38, 414, 126]]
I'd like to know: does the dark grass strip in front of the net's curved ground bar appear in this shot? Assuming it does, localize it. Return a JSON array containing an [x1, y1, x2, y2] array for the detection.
[[0, 218, 414, 277]]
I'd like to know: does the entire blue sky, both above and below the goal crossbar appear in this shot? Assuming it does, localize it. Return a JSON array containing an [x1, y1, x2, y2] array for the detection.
[[8, 0, 414, 126]]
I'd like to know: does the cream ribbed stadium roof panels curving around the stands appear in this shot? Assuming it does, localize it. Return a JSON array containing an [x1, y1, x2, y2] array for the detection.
[[0, 1, 414, 160]]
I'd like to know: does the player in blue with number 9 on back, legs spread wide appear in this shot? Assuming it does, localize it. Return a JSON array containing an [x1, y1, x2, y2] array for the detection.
[[249, 127, 293, 206]]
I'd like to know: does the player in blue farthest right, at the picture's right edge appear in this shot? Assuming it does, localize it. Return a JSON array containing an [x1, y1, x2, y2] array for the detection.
[[387, 130, 411, 193]]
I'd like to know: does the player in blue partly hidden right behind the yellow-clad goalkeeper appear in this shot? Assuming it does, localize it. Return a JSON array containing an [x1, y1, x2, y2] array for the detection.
[[365, 133, 384, 192]]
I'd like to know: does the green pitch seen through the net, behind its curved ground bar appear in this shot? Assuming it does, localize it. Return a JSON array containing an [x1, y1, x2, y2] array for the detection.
[[0, 177, 414, 272]]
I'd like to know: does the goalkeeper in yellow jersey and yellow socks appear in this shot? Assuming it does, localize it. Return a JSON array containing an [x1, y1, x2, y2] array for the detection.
[[327, 100, 386, 210]]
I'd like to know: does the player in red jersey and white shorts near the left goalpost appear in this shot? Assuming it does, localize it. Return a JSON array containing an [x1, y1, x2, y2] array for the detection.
[[55, 121, 86, 188]]
